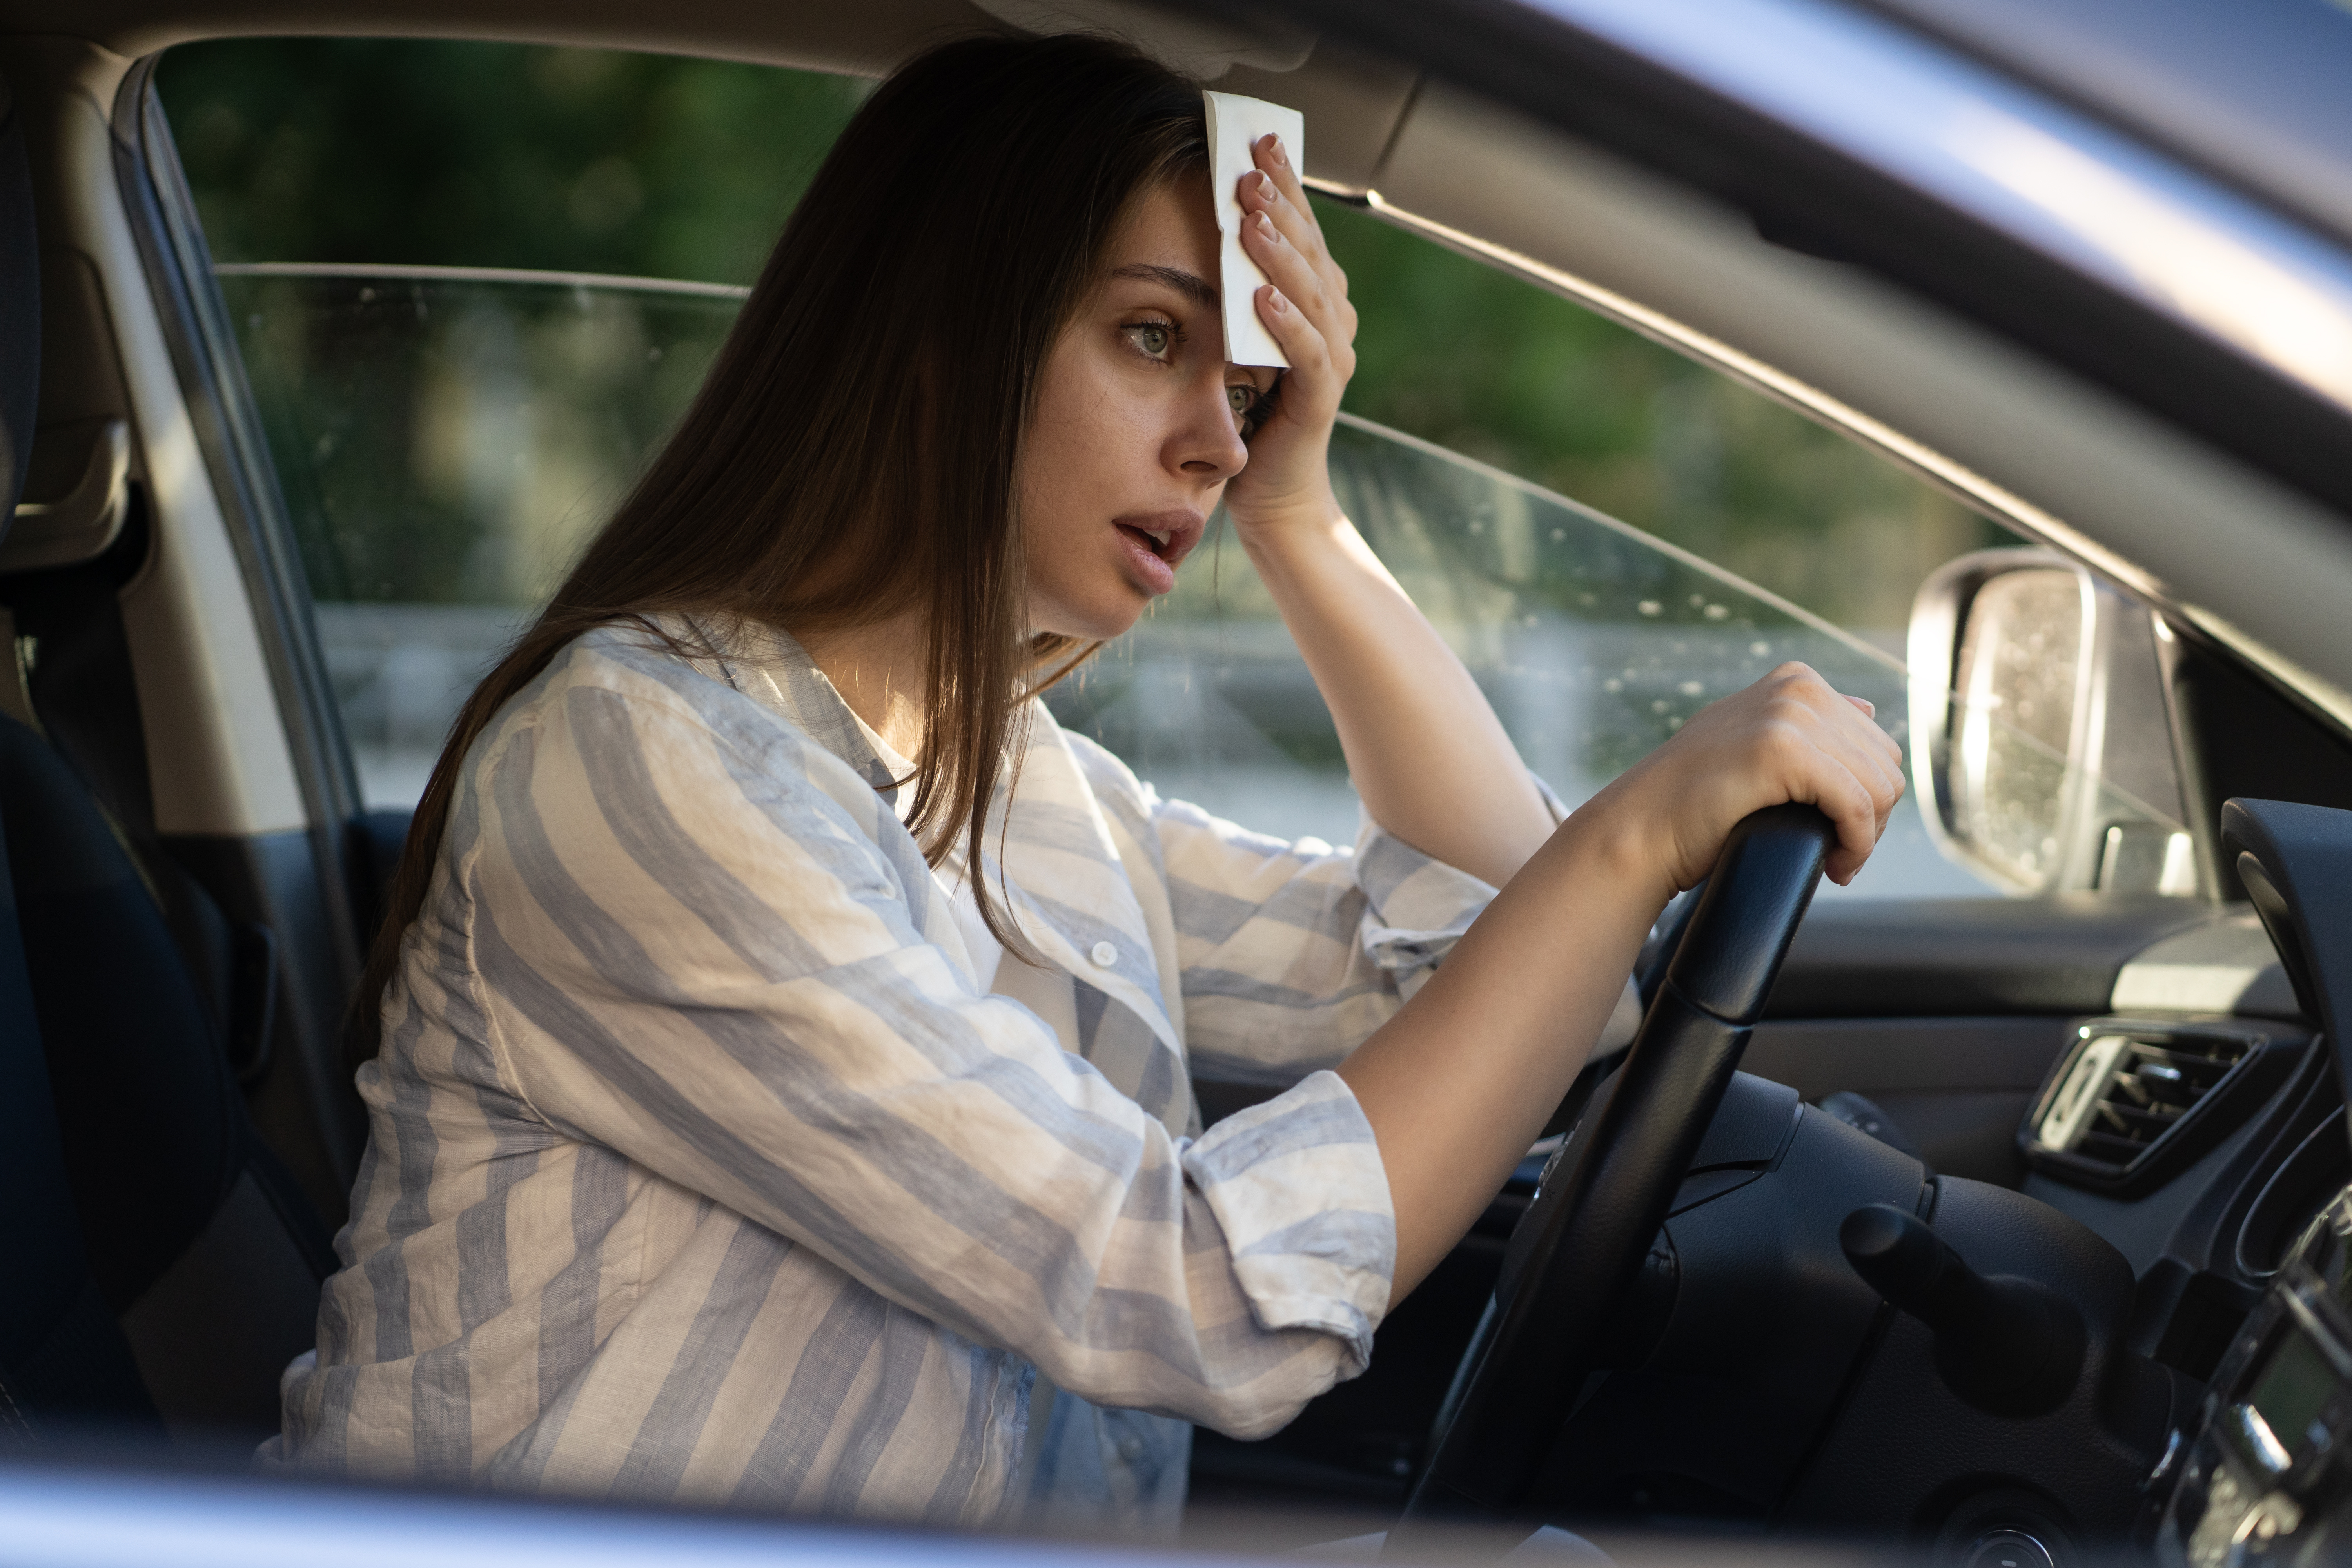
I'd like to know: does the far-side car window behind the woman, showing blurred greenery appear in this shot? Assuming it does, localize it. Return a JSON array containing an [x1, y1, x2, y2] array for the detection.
[[160, 40, 2178, 898]]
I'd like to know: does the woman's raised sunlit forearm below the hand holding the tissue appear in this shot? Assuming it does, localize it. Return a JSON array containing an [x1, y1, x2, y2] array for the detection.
[[1242, 508, 1552, 886]]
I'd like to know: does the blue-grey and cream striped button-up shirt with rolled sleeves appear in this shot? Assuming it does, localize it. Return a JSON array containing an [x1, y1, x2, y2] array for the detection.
[[275, 628, 1524, 1526]]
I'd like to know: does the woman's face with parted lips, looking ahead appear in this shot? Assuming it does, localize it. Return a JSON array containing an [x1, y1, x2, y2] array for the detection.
[[1021, 176, 1275, 637]]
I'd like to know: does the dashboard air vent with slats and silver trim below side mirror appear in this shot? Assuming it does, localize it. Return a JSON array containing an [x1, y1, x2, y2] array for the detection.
[[2020, 1020, 2270, 1185]]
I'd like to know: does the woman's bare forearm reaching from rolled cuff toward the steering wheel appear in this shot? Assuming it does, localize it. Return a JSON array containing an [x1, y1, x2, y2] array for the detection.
[[1338, 790, 1675, 1300]]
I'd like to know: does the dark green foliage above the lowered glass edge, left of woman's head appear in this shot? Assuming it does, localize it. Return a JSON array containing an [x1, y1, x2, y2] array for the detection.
[[155, 38, 868, 282]]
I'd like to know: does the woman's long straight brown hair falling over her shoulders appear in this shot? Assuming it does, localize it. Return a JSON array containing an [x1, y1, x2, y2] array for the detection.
[[350, 35, 1209, 1060]]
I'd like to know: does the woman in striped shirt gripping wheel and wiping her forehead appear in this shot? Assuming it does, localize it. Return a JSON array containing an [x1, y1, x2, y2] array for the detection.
[[282, 40, 1903, 1523]]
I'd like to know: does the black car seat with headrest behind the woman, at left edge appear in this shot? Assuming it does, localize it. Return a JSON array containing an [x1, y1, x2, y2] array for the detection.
[[0, 67, 334, 1443]]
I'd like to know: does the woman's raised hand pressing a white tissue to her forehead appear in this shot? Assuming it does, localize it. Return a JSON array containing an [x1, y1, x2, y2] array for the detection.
[[1225, 136, 1355, 536]]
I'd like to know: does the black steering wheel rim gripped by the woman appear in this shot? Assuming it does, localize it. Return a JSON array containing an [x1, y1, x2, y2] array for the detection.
[[1388, 804, 1837, 1554]]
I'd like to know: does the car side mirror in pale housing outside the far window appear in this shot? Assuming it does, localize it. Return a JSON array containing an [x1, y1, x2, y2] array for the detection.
[[1910, 550, 2199, 896]]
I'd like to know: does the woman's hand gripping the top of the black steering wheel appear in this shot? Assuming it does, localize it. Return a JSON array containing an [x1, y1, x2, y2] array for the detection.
[[1588, 661, 1903, 896]]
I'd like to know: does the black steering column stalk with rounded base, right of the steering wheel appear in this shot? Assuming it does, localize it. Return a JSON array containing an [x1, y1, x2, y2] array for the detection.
[[1837, 1203, 2084, 1415]]
